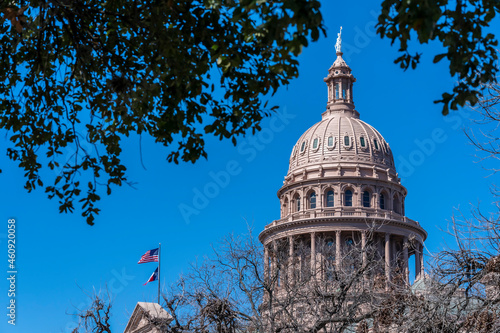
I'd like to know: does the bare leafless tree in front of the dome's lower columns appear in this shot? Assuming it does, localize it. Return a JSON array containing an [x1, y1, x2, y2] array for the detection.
[[158, 228, 416, 333]]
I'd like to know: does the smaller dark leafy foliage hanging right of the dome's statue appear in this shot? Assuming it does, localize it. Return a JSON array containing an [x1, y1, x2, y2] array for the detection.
[[377, 0, 500, 115]]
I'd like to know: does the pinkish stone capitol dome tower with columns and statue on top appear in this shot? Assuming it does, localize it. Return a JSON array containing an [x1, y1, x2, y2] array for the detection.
[[259, 29, 427, 288]]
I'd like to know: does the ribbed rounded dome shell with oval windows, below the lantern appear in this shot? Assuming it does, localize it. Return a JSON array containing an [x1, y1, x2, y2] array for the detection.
[[288, 111, 396, 174]]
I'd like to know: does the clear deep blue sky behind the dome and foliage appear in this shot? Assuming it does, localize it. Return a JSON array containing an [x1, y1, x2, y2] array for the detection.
[[0, 1, 499, 332]]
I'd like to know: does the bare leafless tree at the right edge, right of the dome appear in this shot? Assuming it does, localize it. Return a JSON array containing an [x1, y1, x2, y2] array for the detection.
[[376, 83, 500, 333]]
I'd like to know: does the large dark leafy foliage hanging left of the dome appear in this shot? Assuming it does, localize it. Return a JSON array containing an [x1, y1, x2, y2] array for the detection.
[[0, 0, 325, 225]]
